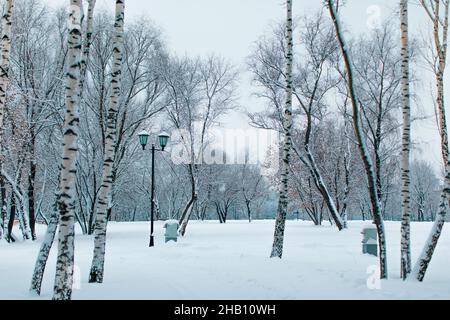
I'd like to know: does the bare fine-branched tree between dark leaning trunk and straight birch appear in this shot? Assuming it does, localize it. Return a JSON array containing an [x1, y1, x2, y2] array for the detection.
[[350, 19, 402, 220]]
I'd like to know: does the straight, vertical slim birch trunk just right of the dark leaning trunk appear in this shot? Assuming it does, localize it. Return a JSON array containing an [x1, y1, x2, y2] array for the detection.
[[400, 0, 411, 280]]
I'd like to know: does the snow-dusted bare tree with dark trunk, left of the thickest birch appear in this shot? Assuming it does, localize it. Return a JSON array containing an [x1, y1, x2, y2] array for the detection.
[[10, 1, 67, 240]]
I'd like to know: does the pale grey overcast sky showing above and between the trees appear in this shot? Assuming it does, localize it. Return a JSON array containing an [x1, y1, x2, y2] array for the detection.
[[45, 0, 450, 174]]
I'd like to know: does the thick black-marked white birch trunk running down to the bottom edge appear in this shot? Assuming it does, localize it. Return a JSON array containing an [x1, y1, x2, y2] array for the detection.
[[53, 0, 82, 300]]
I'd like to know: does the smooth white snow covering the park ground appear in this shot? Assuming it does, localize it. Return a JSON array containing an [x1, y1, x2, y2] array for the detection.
[[0, 221, 450, 300]]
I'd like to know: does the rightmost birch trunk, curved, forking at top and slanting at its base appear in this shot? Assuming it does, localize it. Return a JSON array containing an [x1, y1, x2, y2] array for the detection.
[[412, 0, 450, 281]]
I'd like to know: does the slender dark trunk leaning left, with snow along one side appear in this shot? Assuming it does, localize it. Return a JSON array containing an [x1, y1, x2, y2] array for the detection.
[[327, 0, 388, 279]]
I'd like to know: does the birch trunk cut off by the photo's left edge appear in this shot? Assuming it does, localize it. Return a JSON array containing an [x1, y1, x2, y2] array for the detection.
[[0, 0, 14, 144]]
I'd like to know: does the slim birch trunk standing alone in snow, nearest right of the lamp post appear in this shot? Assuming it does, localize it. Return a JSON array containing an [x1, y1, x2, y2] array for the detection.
[[270, 0, 294, 259]]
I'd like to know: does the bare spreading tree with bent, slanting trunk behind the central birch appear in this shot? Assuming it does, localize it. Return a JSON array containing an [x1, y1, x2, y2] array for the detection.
[[249, 12, 344, 230]]
